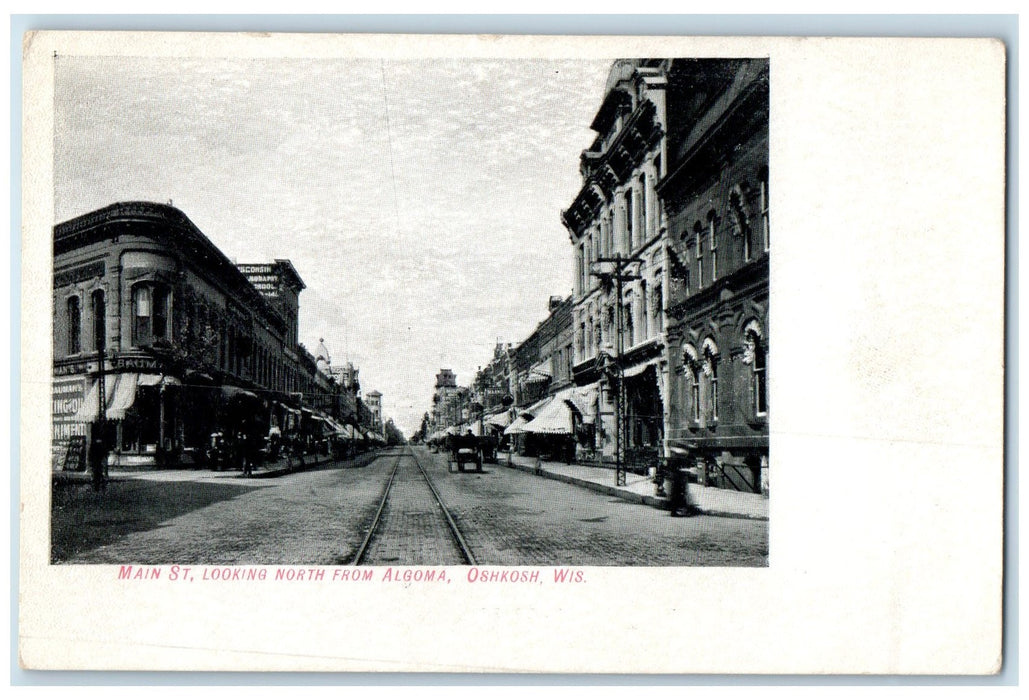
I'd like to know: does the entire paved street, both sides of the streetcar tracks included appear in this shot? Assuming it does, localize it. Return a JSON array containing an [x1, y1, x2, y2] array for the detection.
[[51, 447, 769, 566]]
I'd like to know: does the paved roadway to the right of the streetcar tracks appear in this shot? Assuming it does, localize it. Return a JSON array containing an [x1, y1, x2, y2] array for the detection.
[[414, 447, 769, 566]]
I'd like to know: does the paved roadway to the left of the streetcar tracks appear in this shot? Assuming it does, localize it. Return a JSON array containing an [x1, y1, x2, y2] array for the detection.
[[51, 451, 395, 565]]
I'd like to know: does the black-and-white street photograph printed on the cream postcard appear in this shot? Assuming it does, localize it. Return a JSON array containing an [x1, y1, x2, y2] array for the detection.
[[52, 55, 771, 567]]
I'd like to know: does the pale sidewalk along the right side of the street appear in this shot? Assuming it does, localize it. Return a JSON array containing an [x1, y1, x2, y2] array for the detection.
[[497, 452, 769, 520]]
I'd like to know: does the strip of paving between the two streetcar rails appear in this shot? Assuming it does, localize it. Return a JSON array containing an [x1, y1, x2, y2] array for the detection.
[[361, 455, 465, 566]]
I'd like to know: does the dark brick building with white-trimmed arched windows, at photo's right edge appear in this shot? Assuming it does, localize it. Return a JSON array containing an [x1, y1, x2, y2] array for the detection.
[[658, 59, 771, 494]]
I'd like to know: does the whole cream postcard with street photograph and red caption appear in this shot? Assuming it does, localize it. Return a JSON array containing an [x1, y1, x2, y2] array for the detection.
[[19, 32, 1005, 674]]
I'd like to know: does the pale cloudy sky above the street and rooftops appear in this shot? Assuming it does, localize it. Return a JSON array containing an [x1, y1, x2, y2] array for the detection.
[[56, 57, 610, 434]]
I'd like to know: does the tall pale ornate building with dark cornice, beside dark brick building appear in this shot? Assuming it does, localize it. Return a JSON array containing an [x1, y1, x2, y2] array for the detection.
[[562, 60, 668, 461]]
